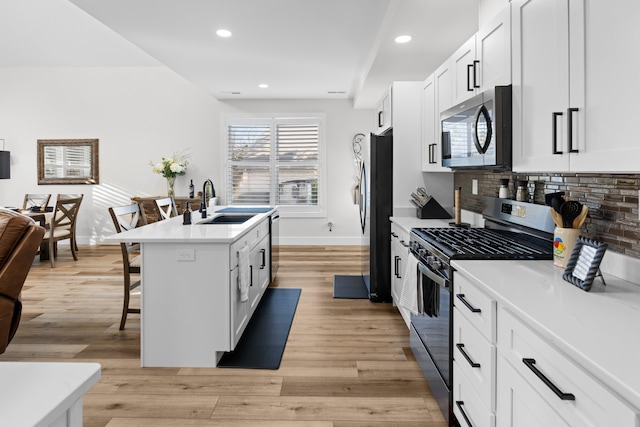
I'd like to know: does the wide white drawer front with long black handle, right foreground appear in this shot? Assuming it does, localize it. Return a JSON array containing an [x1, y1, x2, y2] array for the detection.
[[498, 309, 637, 427]]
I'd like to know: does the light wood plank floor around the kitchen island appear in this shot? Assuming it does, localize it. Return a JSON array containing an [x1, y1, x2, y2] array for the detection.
[[0, 245, 446, 427]]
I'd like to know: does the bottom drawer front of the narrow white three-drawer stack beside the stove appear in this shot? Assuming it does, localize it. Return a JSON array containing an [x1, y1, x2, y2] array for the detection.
[[453, 360, 496, 427]]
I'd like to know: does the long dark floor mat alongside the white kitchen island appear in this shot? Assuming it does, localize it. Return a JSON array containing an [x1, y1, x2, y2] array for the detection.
[[218, 288, 302, 369]]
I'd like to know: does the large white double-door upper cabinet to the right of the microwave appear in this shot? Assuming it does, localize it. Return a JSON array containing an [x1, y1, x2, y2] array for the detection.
[[512, 0, 640, 173]]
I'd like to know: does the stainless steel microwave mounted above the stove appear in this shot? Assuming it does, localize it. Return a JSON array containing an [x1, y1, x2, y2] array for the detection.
[[440, 85, 512, 170]]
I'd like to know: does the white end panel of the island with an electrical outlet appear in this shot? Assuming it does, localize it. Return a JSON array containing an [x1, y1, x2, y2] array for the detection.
[[140, 243, 231, 367]]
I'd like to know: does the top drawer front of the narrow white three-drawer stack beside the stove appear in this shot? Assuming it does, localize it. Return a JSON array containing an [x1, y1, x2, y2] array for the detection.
[[453, 273, 496, 343]]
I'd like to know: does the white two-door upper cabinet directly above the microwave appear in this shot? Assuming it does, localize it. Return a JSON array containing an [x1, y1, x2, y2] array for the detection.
[[449, 5, 511, 105]]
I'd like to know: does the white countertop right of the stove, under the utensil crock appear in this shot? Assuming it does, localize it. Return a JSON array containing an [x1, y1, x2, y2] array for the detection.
[[451, 260, 640, 408]]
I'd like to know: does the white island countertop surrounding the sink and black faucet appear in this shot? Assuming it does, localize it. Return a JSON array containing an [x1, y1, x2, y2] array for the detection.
[[105, 206, 277, 243]]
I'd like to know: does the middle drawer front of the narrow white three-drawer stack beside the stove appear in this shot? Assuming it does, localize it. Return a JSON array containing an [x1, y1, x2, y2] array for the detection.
[[453, 307, 496, 412]]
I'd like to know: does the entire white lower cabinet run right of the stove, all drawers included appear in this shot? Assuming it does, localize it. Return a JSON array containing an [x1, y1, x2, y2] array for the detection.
[[453, 273, 640, 427]]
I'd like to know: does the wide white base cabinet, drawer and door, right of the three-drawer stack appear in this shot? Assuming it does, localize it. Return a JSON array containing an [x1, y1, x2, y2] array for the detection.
[[497, 309, 638, 427]]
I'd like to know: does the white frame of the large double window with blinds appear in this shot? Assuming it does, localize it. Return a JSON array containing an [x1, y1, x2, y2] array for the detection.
[[221, 113, 328, 218]]
